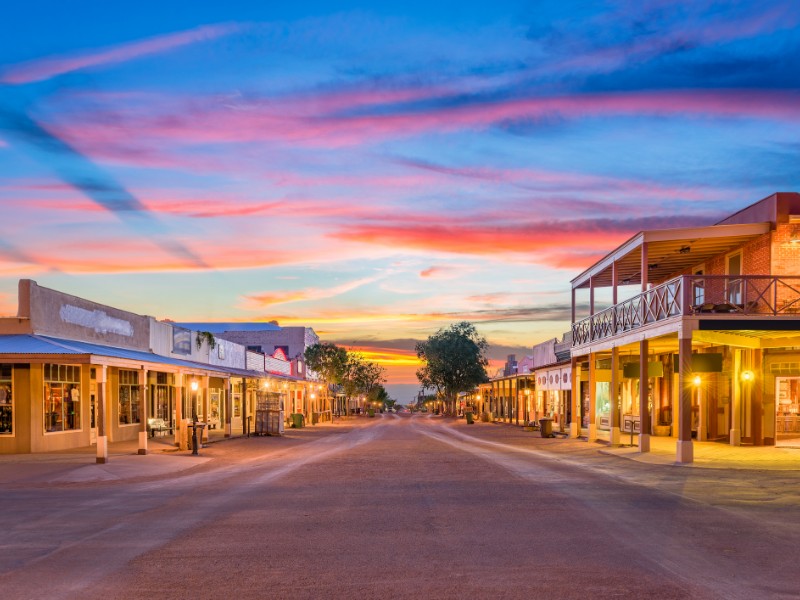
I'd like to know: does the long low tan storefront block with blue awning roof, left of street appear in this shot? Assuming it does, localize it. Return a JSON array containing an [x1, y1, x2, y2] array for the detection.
[[0, 280, 320, 454]]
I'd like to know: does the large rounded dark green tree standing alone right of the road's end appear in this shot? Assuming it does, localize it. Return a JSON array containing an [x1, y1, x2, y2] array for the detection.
[[415, 321, 489, 414]]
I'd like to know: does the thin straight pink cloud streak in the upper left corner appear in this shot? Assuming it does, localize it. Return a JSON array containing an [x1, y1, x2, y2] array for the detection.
[[0, 24, 242, 84]]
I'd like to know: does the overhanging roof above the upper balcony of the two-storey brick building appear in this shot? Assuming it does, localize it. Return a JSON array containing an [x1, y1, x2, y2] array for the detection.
[[572, 223, 770, 289]]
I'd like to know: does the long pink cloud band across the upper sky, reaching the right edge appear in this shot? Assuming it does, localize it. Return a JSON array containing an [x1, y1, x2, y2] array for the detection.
[[53, 90, 800, 148]]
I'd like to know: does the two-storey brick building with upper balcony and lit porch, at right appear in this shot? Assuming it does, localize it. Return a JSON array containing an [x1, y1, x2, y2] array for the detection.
[[572, 193, 800, 462]]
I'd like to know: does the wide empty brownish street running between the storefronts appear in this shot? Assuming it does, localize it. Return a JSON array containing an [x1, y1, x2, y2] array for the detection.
[[0, 415, 800, 599]]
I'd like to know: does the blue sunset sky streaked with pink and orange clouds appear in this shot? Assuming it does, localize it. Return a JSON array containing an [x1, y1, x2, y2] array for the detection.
[[0, 0, 800, 401]]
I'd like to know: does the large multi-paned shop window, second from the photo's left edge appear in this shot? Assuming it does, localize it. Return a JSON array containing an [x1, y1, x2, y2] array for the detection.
[[44, 365, 81, 432]]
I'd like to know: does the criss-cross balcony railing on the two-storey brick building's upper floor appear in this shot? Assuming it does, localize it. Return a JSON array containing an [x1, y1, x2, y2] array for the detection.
[[572, 275, 800, 346]]
